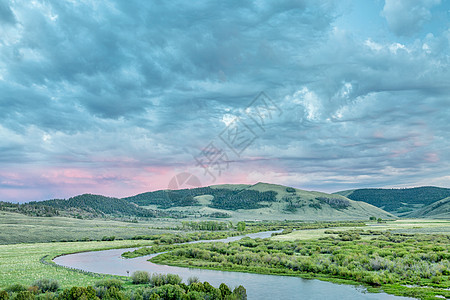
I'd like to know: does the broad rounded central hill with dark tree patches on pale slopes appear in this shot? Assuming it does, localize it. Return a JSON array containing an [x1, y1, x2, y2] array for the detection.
[[124, 183, 395, 220]]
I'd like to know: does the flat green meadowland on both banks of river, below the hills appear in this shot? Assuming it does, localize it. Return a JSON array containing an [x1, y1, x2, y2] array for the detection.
[[0, 218, 450, 299]]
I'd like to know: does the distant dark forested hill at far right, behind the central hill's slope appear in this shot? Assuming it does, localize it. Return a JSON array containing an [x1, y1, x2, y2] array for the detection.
[[335, 186, 450, 216]]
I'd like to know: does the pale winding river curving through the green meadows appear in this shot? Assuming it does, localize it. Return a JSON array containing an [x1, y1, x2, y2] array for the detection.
[[54, 231, 411, 300]]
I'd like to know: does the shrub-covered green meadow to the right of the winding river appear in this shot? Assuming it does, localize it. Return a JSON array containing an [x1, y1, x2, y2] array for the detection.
[[125, 220, 450, 299]]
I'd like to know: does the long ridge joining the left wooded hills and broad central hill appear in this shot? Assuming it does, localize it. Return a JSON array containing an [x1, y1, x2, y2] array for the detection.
[[0, 182, 396, 221]]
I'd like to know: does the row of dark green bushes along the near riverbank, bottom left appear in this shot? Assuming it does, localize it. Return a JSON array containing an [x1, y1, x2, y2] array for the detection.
[[0, 271, 247, 300]]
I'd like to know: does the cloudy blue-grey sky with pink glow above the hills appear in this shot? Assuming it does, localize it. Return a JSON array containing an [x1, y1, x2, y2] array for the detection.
[[0, 0, 450, 202]]
